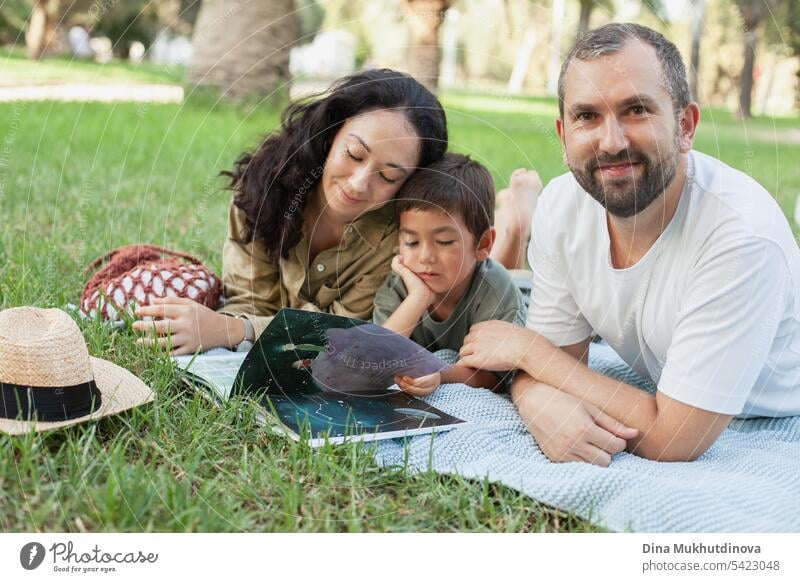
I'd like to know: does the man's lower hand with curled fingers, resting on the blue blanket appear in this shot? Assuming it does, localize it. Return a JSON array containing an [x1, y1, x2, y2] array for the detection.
[[511, 376, 638, 467]]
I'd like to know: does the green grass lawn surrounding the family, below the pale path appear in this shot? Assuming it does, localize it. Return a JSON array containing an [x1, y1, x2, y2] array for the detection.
[[0, 88, 800, 531]]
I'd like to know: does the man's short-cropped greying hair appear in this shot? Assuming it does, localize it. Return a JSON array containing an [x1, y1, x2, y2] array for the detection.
[[558, 23, 691, 119]]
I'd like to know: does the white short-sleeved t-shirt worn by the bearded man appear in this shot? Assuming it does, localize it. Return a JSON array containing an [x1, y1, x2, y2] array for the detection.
[[527, 151, 800, 417]]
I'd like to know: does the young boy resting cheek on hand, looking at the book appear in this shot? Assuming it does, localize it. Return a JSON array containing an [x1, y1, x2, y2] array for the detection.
[[373, 153, 525, 396]]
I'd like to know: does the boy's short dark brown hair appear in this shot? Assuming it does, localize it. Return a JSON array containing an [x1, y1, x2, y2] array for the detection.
[[395, 153, 494, 243]]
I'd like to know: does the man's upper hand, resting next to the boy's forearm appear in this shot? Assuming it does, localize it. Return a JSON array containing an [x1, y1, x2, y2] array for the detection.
[[458, 321, 557, 372]]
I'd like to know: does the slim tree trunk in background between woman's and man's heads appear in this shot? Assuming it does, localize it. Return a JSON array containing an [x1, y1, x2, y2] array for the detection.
[[403, 0, 451, 92]]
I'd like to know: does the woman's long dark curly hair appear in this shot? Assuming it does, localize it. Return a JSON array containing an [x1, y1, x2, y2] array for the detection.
[[221, 69, 447, 264]]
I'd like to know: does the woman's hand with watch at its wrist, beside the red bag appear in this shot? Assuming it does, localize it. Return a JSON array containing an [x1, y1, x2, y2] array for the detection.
[[133, 297, 245, 356]]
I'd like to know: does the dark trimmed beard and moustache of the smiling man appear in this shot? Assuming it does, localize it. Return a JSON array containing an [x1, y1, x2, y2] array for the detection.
[[569, 135, 680, 218]]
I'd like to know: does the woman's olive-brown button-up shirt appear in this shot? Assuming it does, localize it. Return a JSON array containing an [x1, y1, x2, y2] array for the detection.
[[220, 204, 398, 337]]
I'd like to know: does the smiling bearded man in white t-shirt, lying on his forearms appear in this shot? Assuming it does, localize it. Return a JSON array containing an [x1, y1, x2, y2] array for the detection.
[[459, 24, 800, 466]]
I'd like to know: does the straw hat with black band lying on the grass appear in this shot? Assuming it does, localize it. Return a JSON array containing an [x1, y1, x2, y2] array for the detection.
[[0, 307, 153, 434]]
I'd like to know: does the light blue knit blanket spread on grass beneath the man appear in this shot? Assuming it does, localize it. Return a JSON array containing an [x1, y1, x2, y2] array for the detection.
[[375, 344, 800, 532]]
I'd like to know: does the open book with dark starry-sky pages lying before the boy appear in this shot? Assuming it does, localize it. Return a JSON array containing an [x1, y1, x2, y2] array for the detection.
[[173, 309, 464, 446]]
